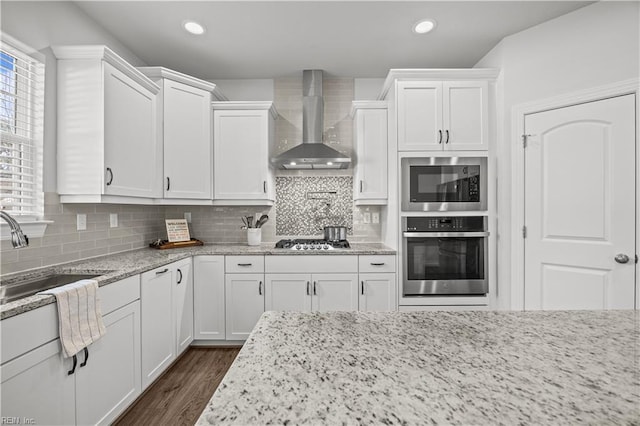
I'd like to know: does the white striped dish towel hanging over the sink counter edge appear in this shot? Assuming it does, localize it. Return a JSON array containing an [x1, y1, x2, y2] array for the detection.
[[38, 280, 107, 358]]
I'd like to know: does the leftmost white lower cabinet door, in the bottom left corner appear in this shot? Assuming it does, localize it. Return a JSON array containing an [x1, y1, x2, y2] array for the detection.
[[0, 339, 76, 425]]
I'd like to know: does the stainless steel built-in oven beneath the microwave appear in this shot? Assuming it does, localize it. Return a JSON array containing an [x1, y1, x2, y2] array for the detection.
[[402, 216, 489, 297]]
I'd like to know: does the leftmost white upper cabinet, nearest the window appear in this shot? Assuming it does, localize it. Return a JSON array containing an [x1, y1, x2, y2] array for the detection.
[[53, 45, 162, 203]]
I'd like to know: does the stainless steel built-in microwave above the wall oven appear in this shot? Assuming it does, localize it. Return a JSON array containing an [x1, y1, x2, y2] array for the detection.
[[400, 157, 487, 211]]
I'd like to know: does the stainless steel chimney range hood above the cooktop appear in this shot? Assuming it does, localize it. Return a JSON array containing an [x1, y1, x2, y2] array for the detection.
[[271, 70, 351, 170]]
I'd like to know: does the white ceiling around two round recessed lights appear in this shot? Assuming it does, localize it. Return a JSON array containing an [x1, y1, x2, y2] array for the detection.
[[76, 0, 592, 80]]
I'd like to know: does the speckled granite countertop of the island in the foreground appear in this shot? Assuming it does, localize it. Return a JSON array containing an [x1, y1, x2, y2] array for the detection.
[[198, 311, 640, 425]]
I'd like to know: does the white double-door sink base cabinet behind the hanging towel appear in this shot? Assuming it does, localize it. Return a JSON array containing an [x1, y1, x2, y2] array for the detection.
[[0, 275, 141, 425]]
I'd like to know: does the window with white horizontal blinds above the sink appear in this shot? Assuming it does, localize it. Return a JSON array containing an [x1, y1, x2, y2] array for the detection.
[[0, 34, 44, 220]]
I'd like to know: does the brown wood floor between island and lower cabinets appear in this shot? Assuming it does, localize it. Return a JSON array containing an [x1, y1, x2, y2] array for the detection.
[[114, 347, 240, 426]]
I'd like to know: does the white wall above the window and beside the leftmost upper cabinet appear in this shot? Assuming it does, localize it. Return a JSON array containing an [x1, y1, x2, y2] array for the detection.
[[0, 1, 145, 192]]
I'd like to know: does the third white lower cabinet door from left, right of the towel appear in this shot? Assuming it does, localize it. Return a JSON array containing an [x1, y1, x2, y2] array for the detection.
[[140, 266, 176, 389]]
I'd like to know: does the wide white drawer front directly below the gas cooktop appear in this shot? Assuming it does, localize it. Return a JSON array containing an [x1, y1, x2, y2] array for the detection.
[[265, 255, 358, 274]]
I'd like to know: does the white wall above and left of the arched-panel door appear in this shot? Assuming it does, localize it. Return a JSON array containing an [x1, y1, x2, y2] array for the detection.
[[476, 1, 640, 309]]
